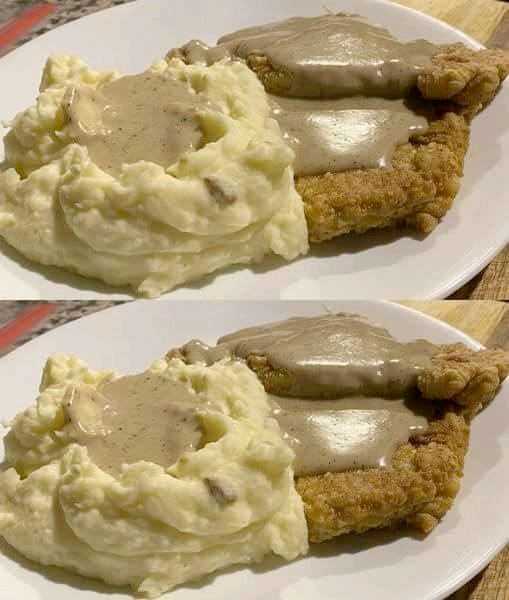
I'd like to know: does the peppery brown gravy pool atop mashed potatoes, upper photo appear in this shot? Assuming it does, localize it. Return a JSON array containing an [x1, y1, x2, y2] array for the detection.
[[64, 72, 210, 172]]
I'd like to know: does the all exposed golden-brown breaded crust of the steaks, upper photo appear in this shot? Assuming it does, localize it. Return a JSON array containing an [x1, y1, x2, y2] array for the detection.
[[247, 44, 509, 242]]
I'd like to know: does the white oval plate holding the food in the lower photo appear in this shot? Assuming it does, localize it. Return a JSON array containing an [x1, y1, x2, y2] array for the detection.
[[0, 301, 509, 600]]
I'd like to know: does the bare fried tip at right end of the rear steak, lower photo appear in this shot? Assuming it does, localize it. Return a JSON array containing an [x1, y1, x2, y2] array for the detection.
[[417, 344, 509, 419]]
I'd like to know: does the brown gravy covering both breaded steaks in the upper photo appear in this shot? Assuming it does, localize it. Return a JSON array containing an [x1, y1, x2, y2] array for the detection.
[[169, 14, 440, 176]]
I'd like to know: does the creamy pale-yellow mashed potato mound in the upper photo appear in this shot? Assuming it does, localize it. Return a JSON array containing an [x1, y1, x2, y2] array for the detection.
[[0, 56, 308, 297]]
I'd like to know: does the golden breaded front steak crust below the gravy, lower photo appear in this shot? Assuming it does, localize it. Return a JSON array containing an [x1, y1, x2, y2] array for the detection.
[[296, 412, 469, 542]]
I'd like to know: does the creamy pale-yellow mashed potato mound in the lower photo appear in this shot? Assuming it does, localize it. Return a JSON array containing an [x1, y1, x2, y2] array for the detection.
[[0, 356, 307, 596]]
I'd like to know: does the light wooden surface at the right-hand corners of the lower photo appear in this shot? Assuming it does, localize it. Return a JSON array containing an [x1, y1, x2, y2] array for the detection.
[[402, 300, 509, 600]]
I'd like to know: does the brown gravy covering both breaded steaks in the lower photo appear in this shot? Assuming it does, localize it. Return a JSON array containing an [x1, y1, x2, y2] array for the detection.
[[182, 313, 432, 476]]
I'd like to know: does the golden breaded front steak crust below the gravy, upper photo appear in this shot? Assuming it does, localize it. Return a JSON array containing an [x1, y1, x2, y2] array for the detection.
[[296, 113, 469, 242]]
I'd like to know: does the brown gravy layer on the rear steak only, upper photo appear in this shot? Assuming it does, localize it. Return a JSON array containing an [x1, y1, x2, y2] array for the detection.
[[215, 14, 439, 98]]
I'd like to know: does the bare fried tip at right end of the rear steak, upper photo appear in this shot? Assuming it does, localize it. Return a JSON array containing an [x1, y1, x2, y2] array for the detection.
[[417, 44, 509, 119]]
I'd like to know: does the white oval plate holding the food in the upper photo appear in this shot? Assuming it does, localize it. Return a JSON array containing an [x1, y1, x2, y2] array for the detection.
[[0, 0, 509, 299]]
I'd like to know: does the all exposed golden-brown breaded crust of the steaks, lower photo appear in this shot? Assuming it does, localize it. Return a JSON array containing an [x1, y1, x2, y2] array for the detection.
[[171, 344, 509, 542]]
